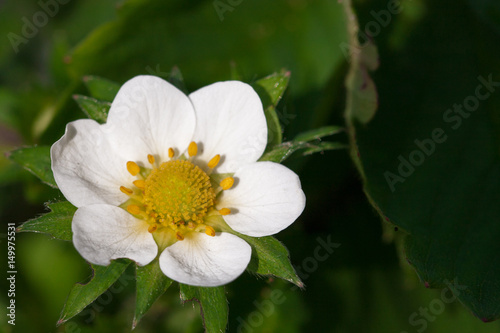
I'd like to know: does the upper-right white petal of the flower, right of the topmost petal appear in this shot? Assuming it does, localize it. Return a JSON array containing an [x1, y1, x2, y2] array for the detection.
[[189, 81, 267, 173]]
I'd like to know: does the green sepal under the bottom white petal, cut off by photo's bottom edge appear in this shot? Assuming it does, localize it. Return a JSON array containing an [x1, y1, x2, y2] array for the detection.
[[180, 284, 229, 333]]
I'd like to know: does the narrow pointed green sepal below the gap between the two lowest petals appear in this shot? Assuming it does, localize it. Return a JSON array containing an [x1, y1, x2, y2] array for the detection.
[[132, 259, 172, 329]]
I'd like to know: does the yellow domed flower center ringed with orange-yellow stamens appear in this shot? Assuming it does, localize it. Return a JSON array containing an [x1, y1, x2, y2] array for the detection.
[[120, 142, 234, 240]]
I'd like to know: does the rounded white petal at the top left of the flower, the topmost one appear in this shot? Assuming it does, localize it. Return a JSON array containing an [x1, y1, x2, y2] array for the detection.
[[107, 75, 196, 163]]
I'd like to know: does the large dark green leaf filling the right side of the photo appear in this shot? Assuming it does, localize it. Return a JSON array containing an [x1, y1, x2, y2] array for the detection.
[[346, 1, 500, 321]]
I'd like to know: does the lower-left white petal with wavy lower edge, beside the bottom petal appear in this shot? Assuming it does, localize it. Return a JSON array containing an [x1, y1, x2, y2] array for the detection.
[[71, 205, 158, 266]]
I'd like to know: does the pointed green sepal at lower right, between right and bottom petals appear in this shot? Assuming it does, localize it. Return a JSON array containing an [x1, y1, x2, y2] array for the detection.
[[238, 234, 304, 288]]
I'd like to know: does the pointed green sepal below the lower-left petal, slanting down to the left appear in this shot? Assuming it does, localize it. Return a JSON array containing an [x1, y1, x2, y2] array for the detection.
[[57, 259, 131, 325]]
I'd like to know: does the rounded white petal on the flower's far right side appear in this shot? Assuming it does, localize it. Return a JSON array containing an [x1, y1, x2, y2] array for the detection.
[[217, 162, 306, 237]]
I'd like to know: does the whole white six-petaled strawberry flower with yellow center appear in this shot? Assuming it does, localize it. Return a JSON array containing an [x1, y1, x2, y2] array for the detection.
[[51, 76, 305, 286]]
